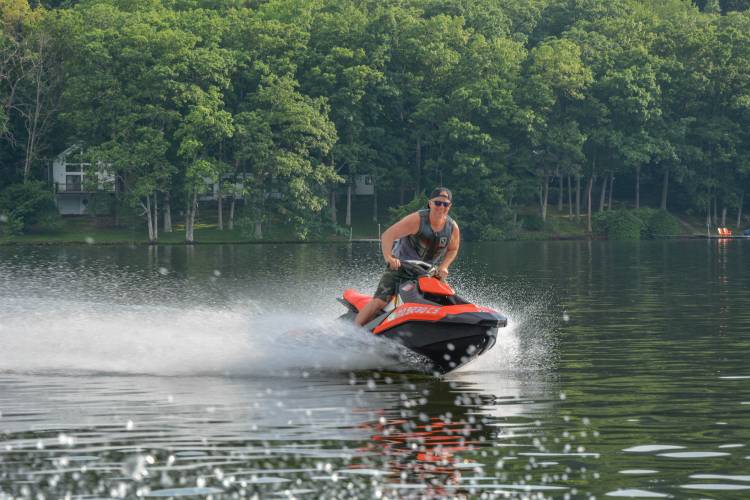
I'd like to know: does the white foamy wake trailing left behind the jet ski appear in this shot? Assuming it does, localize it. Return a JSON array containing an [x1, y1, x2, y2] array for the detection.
[[0, 297, 412, 375]]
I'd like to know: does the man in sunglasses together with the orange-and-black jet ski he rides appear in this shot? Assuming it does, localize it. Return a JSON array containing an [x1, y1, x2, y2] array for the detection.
[[342, 187, 507, 373]]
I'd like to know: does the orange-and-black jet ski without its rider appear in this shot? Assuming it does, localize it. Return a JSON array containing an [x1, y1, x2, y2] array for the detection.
[[338, 260, 508, 374]]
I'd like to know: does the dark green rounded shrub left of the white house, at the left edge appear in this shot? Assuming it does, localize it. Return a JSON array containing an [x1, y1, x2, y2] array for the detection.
[[0, 181, 59, 234]]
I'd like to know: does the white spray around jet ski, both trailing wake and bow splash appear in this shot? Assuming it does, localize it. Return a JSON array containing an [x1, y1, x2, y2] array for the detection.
[[0, 252, 553, 376]]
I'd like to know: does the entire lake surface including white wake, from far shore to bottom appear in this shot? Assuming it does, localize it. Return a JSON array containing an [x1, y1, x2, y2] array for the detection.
[[0, 241, 750, 499]]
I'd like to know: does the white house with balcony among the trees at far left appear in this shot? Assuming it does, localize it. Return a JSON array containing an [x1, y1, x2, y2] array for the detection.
[[52, 144, 115, 215]]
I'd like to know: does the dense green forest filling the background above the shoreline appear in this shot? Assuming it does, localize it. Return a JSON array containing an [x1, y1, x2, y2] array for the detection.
[[0, 0, 750, 241]]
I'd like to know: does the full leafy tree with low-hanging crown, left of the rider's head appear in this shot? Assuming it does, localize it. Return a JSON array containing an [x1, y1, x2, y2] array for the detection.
[[235, 76, 339, 239]]
